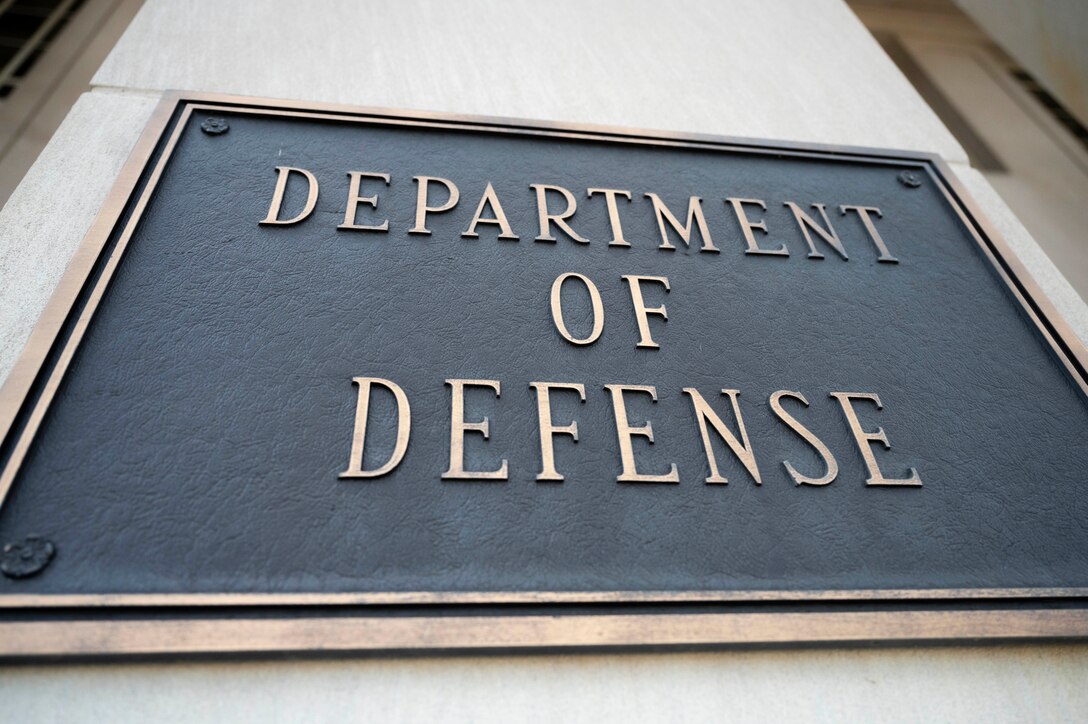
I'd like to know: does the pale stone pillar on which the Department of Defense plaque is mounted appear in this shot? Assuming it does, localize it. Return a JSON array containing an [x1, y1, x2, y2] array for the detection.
[[0, 0, 1088, 722]]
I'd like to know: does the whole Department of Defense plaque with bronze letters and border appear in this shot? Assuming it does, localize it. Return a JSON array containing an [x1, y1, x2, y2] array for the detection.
[[0, 91, 1088, 655]]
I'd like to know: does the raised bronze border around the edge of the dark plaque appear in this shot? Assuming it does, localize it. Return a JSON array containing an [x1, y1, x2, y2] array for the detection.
[[0, 91, 1088, 659]]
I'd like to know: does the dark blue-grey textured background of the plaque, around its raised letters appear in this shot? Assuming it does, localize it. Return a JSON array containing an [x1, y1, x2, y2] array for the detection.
[[0, 95, 1088, 614]]
